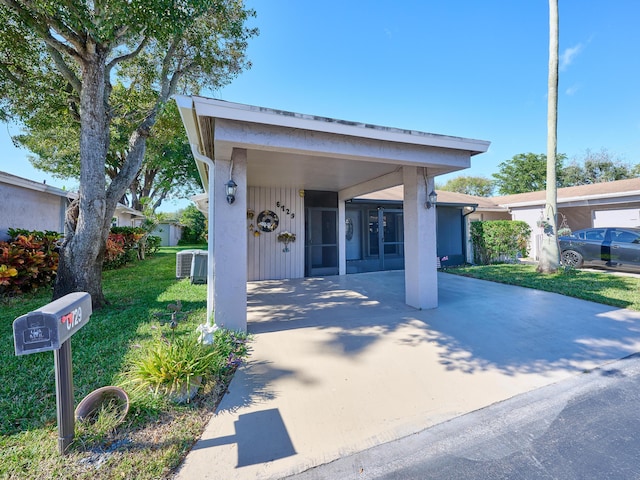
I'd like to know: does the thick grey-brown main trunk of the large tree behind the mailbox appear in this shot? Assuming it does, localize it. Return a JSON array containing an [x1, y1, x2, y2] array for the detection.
[[53, 46, 110, 309]]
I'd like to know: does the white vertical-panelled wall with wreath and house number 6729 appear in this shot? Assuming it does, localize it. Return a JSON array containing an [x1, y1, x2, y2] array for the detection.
[[247, 187, 305, 281]]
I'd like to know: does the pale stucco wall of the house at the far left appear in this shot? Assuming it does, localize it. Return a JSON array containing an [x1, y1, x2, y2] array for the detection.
[[0, 182, 67, 240]]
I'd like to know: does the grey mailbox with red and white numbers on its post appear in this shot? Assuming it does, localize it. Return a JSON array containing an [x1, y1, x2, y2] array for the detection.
[[13, 292, 92, 454]]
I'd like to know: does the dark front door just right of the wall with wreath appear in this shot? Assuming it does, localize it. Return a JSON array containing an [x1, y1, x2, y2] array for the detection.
[[305, 207, 338, 277]]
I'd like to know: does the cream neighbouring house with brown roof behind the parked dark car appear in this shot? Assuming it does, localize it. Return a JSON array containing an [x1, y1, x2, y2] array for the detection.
[[490, 178, 640, 260]]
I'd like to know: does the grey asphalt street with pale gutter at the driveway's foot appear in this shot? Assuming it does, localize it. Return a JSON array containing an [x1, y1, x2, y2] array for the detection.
[[288, 355, 640, 480]]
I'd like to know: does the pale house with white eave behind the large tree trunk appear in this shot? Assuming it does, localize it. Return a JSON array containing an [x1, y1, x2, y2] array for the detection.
[[0, 172, 144, 240]]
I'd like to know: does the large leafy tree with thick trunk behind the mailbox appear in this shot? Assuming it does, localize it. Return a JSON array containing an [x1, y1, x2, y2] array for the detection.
[[0, 0, 256, 307]]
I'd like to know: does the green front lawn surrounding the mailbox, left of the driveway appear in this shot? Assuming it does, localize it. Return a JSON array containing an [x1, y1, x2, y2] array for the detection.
[[0, 247, 240, 479]]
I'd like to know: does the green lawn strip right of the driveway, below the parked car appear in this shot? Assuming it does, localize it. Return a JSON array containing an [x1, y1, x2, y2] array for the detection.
[[446, 264, 640, 310]]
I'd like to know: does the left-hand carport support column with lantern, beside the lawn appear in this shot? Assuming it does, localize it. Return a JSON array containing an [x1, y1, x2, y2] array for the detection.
[[209, 148, 247, 332]]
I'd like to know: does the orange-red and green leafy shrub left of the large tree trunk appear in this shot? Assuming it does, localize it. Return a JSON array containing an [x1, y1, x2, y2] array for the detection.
[[0, 229, 62, 295]]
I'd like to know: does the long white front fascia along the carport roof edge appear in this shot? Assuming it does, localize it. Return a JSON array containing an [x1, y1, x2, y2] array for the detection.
[[188, 97, 491, 155]]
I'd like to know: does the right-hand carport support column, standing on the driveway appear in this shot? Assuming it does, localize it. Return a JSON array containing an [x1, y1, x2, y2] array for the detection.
[[402, 167, 438, 309]]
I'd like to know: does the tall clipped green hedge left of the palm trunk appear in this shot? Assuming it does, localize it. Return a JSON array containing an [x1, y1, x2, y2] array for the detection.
[[471, 220, 531, 265]]
